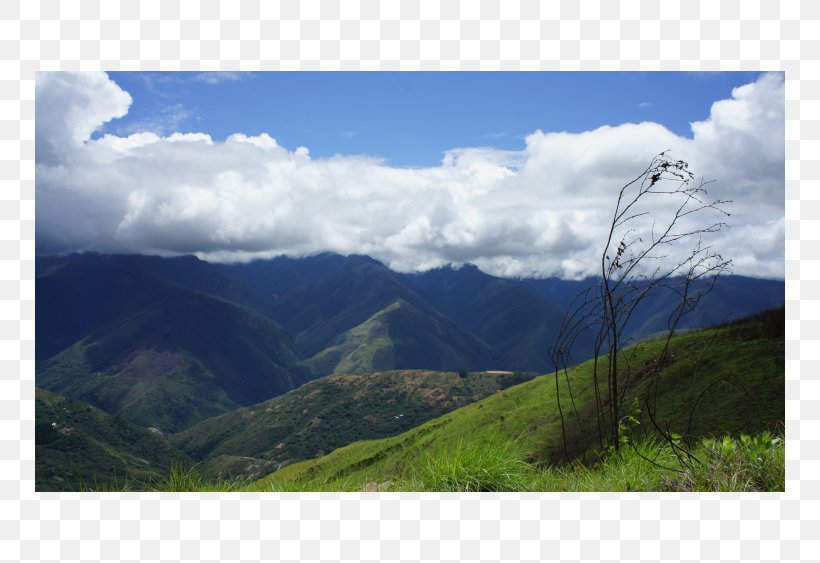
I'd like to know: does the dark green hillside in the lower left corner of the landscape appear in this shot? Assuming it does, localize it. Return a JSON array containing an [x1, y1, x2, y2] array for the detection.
[[34, 389, 190, 491]]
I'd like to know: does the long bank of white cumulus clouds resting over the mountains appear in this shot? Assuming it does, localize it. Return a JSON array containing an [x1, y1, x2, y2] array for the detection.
[[36, 73, 785, 277]]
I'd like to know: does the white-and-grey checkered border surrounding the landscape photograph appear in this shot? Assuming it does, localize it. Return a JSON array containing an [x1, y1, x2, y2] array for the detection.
[[0, 0, 820, 561]]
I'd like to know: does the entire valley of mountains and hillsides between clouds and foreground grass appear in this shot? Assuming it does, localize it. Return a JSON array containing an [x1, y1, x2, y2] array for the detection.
[[35, 253, 784, 490]]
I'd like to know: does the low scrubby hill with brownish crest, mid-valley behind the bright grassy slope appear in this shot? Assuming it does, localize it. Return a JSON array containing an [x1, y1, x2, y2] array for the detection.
[[171, 371, 533, 480]]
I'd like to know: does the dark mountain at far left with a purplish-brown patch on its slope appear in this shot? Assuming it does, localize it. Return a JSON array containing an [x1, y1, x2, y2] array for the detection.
[[36, 265, 312, 432]]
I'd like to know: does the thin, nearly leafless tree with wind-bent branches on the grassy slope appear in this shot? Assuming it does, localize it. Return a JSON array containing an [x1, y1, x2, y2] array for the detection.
[[550, 153, 731, 460]]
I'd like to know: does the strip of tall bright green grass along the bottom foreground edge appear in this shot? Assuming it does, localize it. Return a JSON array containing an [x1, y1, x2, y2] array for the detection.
[[125, 432, 785, 492]]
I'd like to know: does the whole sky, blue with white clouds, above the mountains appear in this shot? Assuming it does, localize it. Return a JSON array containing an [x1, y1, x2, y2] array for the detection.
[[35, 72, 785, 279]]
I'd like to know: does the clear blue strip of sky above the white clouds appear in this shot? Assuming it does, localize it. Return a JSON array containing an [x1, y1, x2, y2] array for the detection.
[[97, 72, 759, 167]]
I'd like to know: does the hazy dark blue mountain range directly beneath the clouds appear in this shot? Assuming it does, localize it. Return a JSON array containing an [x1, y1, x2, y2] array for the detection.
[[36, 253, 784, 433]]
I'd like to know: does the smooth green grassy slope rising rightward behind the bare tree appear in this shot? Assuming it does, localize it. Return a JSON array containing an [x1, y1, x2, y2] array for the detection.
[[249, 309, 785, 490]]
